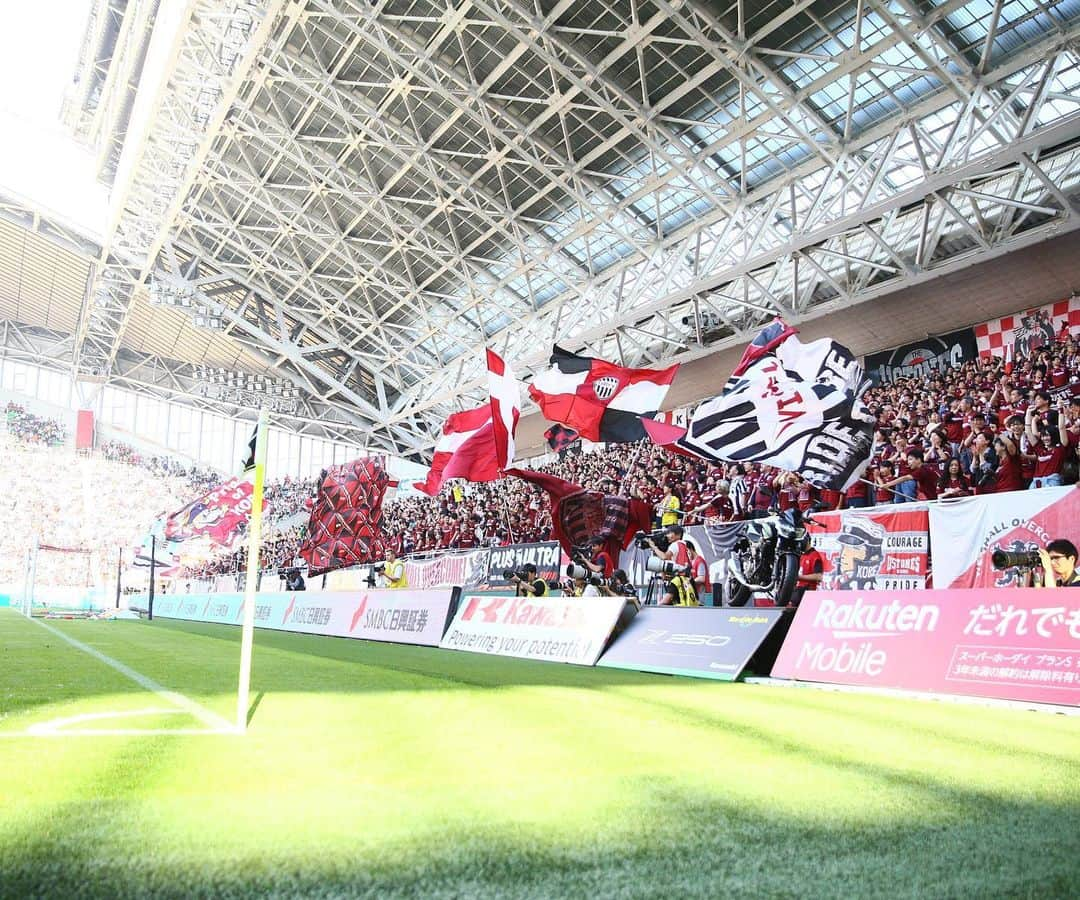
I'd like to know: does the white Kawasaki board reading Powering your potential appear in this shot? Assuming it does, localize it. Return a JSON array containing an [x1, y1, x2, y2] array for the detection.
[[441, 595, 626, 666]]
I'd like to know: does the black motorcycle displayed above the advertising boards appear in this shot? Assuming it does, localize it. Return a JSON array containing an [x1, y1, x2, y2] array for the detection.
[[727, 507, 819, 606]]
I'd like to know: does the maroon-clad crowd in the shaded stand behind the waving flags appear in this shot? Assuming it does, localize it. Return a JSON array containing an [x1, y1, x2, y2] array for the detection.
[[185, 334, 1080, 572]]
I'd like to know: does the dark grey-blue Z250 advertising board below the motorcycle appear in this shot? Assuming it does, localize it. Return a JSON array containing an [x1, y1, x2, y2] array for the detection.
[[597, 606, 791, 682]]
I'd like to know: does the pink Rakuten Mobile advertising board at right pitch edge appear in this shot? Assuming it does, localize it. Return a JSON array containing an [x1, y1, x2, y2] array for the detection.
[[772, 588, 1080, 706]]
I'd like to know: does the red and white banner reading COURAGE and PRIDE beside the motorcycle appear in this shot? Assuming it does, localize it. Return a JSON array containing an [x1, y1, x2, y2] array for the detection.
[[810, 503, 930, 591]]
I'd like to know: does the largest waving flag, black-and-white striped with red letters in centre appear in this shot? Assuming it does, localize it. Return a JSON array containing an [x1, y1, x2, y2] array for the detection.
[[647, 319, 874, 491]]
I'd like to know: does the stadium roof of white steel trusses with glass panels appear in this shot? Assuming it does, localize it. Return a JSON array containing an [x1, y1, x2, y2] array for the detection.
[[0, 0, 1080, 455]]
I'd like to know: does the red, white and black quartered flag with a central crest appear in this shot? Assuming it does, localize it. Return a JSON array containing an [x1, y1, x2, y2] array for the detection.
[[529, 346, 678, 443]]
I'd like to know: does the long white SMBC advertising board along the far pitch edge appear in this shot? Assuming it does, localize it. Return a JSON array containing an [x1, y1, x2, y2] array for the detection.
[[153, 590, 450, 647]]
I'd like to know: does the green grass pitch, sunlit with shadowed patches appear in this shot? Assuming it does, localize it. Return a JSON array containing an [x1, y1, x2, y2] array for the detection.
[[0, 610, 1080, 898]]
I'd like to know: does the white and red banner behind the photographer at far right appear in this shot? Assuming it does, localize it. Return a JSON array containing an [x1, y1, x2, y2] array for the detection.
[[930, 487, 1080, 588]]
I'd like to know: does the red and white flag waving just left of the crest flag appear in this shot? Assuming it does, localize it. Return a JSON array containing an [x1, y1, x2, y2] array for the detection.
[[414, 350, 521, 497]]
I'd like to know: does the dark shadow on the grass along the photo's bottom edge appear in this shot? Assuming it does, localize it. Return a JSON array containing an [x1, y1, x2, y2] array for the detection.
[[0, 762, 1080, 898]]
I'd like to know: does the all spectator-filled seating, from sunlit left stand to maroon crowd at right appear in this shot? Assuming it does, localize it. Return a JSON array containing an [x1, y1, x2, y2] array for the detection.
[[0, 336, 1080, 578]]
